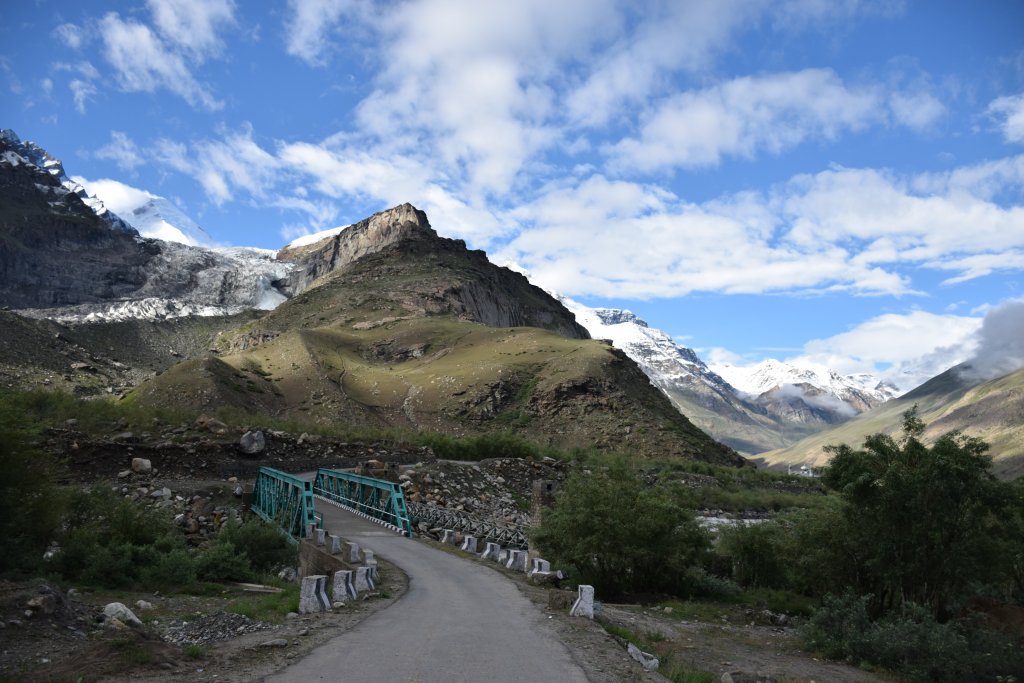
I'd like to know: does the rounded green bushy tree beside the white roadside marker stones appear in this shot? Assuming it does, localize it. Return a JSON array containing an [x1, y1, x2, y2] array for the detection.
[[532, 468, 709, 597]]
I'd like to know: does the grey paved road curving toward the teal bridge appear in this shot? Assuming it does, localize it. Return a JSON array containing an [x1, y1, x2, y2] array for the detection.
[[266, 501, 587, 683]]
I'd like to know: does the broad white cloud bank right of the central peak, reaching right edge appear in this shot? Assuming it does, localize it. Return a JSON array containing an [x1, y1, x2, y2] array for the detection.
[[499, 157, 1024, 298]]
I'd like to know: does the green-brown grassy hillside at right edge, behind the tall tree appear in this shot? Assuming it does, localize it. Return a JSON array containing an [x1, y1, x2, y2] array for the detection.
[[760, 369, 1024, 476]]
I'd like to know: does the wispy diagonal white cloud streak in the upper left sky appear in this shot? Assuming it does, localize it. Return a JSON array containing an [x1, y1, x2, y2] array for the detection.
[[99, 12, 223, 110]]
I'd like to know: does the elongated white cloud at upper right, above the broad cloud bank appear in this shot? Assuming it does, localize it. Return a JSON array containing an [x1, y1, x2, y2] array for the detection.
[[609, 69, 881, 171]]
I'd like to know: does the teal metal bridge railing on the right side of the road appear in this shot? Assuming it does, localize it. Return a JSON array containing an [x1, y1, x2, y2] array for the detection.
[[313, 468, 413, 536]]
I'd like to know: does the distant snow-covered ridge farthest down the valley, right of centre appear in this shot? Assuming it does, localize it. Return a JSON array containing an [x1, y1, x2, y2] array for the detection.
[[712, 358, 899, 405]]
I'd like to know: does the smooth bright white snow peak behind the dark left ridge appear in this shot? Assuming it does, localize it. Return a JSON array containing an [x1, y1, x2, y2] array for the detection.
[[72, 176, 213, 247]]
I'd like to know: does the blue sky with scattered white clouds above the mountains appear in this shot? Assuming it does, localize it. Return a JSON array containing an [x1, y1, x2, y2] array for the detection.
[[0, 0, 1024, 389]]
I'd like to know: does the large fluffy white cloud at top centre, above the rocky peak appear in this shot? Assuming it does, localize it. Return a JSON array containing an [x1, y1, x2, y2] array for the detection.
[[358, 0, 613, 194]]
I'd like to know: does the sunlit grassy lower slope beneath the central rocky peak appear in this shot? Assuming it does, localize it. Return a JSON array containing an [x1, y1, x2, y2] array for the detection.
[[135, 316, 731, 462]]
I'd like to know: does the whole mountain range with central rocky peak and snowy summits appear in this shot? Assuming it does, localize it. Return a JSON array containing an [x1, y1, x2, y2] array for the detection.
[[0, 130, 1016, 466]]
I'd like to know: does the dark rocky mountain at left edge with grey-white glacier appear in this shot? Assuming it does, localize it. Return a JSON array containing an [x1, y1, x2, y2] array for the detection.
[[0, 130, 295, 322]]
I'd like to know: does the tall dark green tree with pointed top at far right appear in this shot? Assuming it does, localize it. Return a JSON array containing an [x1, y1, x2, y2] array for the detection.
[[823, 409, 1013, 618]]
